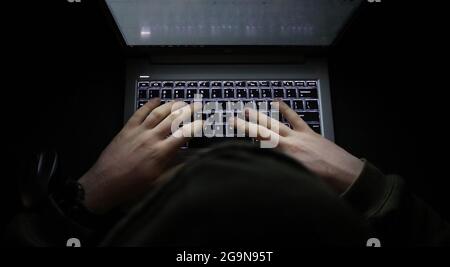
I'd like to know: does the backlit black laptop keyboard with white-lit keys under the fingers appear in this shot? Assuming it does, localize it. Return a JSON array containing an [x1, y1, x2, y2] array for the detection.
[[135, 79, 321, 142]]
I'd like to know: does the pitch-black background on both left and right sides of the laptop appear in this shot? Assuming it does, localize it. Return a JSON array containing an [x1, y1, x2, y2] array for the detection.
[[1, 0, 450, 234]]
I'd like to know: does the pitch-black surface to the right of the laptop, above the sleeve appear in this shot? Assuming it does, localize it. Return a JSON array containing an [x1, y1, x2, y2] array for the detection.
[[330, 1, 450, 219]]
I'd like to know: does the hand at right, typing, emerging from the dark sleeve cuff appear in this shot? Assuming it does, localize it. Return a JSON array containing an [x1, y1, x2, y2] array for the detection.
[[232, 101, 364, 193]]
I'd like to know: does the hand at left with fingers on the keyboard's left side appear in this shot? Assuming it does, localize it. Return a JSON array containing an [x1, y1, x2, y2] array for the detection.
[[79, 99, 202, 214]]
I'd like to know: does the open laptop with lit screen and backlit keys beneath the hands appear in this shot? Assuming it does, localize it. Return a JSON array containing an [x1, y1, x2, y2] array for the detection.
[[105, 0, 362, 147]]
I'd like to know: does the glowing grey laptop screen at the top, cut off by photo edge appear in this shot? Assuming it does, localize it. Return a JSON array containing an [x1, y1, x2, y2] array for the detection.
[[106, 0, 362, 46]]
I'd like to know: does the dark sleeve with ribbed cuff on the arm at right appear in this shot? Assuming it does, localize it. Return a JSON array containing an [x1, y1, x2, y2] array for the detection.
[[342, 161, 450, 246]]
